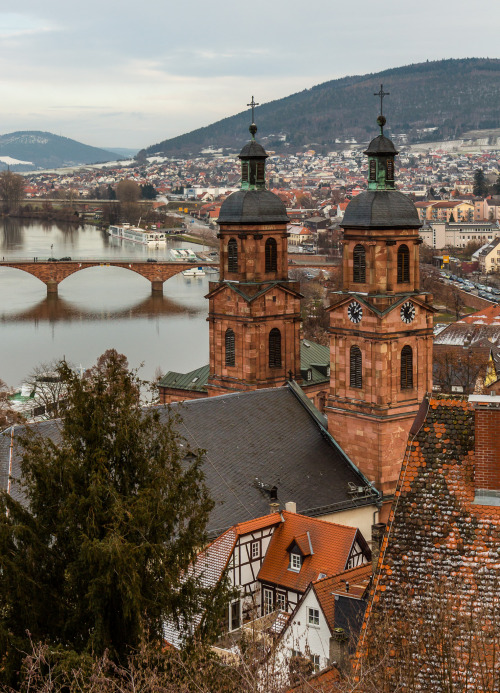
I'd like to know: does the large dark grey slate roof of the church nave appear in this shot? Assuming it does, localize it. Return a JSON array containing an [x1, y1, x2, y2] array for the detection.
[[0, 387, 375, 534]]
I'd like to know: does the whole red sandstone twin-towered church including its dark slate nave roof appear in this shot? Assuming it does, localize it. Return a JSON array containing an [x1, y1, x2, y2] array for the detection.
[[0, 102, 434, 537]]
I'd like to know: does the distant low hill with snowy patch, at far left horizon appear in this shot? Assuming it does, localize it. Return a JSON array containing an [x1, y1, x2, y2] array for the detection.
[[0, 130, 117, 171]]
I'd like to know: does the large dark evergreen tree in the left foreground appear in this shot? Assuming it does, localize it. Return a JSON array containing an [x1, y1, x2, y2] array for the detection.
[[0, 350, 228, 682]]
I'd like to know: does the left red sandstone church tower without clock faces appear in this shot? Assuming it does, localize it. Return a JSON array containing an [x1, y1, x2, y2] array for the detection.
[[207, 111, 301, 396]]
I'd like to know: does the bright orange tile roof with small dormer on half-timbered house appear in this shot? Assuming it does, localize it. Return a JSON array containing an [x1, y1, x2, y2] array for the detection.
[[258, 511, 358, 592]]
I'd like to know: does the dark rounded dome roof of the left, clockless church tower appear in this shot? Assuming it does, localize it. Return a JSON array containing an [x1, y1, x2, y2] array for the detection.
[[218, 190, 290, 224]]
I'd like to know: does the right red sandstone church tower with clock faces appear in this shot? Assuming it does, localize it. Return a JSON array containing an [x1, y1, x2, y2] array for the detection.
[[326, 108, 434, 497]]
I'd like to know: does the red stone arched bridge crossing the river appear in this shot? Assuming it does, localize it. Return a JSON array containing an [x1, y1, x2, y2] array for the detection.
[[0, 260, 219, 294]]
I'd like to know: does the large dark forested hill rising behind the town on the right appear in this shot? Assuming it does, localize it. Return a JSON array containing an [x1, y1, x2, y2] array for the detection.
[[146, 58, 500, 155]]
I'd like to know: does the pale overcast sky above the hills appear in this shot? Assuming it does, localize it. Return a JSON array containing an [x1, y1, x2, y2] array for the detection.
[[0, 0, 500, 148]]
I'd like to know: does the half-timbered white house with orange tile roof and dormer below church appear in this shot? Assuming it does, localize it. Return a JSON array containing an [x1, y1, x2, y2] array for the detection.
[[166, 503, 371, 648]]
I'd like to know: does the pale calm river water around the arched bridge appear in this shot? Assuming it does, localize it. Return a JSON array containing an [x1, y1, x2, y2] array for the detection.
[[0, 219, 213, 385]]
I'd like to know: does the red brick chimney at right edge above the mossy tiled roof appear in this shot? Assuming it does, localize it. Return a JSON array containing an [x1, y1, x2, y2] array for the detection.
[[469, 395, 500, 505]]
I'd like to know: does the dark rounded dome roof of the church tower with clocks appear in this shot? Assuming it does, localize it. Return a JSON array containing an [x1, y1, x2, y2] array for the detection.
[[341, 190, 422, 229]]
